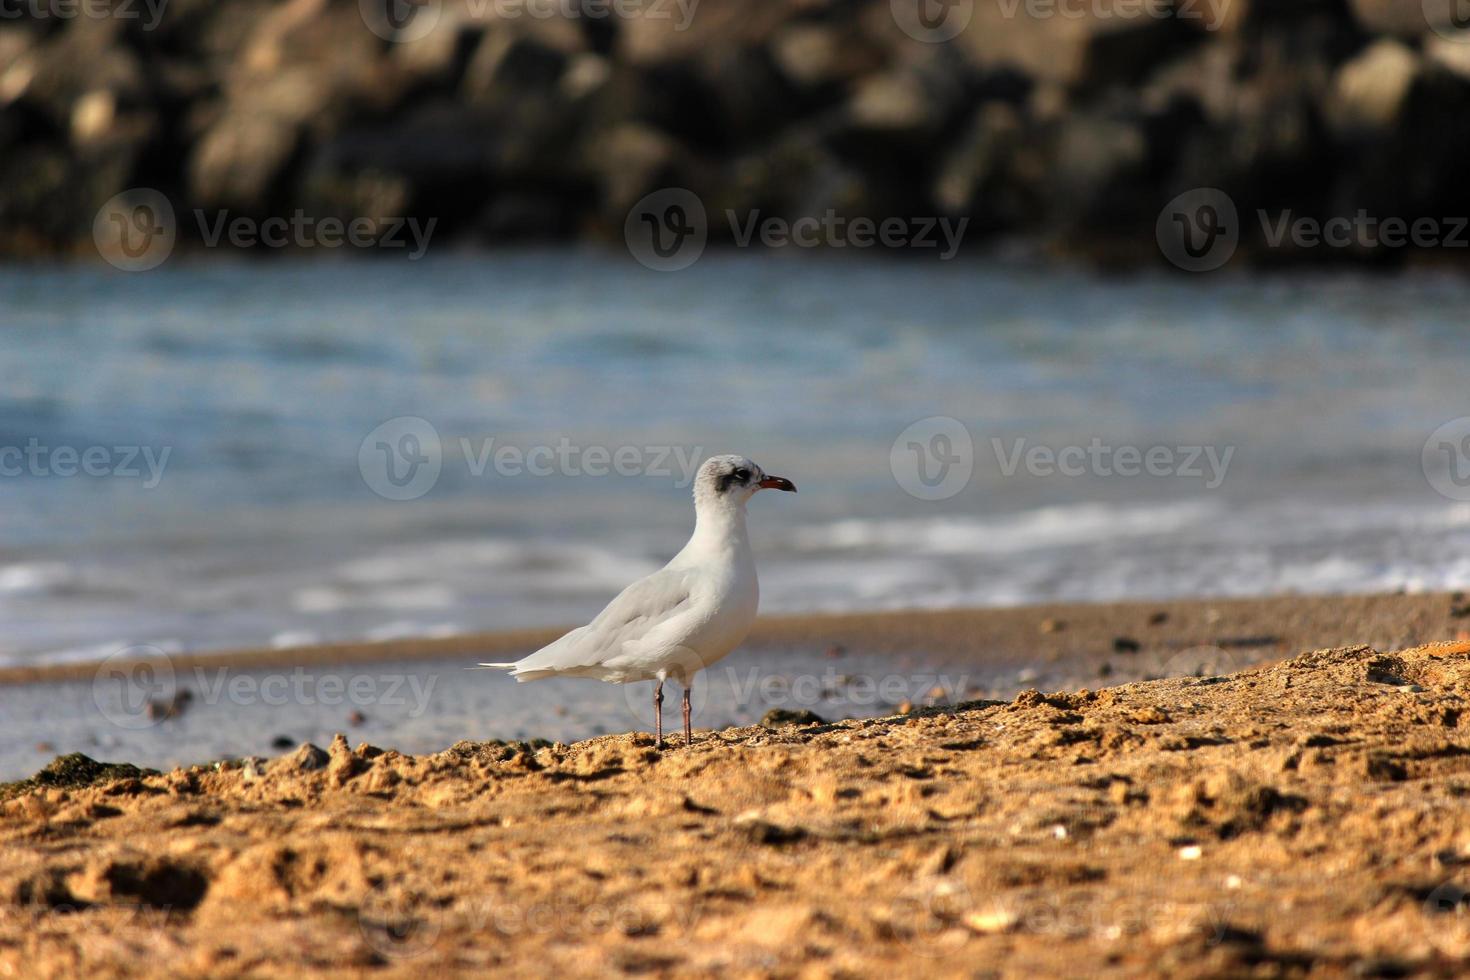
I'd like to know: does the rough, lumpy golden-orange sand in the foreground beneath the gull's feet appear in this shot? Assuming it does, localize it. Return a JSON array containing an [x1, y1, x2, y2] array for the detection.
[[0, 595, 1470, 977]]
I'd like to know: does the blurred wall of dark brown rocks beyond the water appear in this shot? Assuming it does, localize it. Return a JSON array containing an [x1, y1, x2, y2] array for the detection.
[[0, 0, 1470, 263]]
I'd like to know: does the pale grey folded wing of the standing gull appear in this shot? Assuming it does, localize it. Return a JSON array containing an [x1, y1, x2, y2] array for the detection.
[[485, 569, 697, 680]]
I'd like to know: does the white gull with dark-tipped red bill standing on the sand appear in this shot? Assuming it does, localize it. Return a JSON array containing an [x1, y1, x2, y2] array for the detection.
[[479, 455, 797, 749]]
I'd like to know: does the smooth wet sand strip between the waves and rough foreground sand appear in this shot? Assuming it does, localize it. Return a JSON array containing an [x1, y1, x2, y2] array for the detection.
[[0, 594, 1470, 782]]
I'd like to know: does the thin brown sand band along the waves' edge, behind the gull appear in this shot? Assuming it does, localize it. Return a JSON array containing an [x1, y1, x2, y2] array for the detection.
[[0, 592, 1470, 686]]
